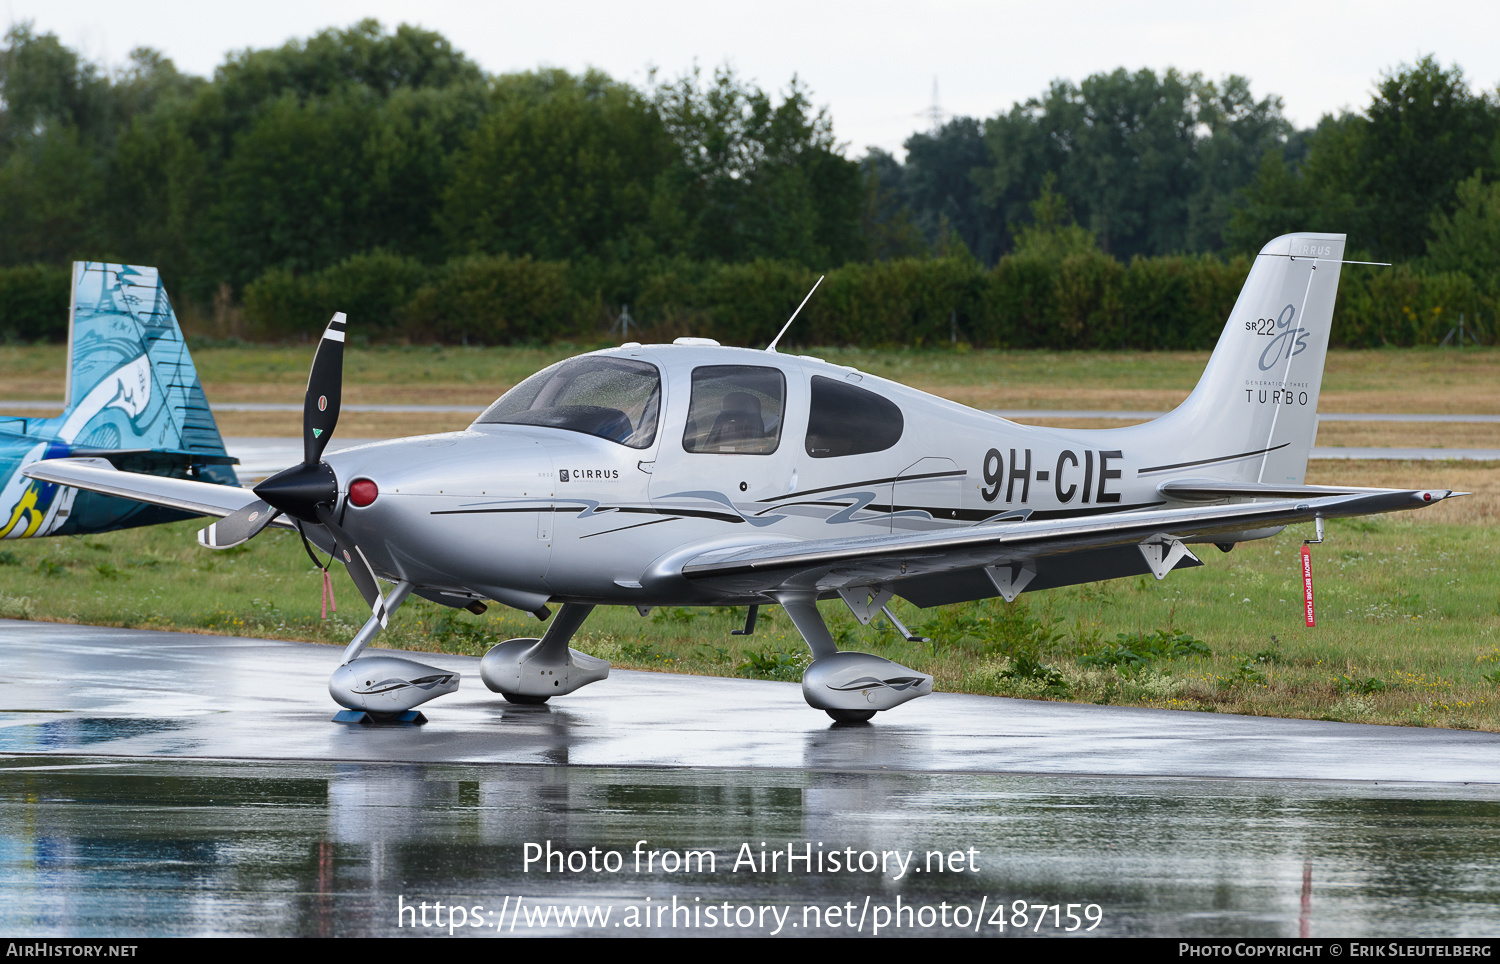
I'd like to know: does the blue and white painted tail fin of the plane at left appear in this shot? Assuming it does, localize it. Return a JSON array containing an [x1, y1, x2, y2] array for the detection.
[[57, 261, 239, 484]]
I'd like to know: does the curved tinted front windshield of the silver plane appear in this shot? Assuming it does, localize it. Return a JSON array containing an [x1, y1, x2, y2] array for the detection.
[[474, 357, 662, 448]]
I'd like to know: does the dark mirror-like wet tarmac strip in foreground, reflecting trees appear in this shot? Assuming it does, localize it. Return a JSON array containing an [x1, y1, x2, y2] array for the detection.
[[0, 757, 1500, 937]]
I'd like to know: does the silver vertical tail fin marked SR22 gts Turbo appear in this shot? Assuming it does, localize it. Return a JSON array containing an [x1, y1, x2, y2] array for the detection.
[[1142, 234, 1344, 484]]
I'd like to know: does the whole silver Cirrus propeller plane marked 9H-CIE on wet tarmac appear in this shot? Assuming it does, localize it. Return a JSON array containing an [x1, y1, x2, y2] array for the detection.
[[26, 234, 1454, 721]]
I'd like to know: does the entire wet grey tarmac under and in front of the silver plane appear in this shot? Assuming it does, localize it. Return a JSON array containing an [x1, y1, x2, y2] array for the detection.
[[0, 621, 1500, 937]]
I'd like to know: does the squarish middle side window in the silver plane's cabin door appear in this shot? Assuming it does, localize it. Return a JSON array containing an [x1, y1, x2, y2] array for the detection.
[[683, 364, 786, 456]]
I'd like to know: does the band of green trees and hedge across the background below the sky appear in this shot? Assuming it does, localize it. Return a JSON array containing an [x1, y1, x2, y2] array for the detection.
[[0, 21, 1500, 346]]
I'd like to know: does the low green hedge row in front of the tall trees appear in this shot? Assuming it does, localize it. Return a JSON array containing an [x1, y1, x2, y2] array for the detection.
[[0, 252, 1500, 349]]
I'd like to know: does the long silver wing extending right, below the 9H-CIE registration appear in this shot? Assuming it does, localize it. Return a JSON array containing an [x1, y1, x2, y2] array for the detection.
[[681, 489, 1463, 594]]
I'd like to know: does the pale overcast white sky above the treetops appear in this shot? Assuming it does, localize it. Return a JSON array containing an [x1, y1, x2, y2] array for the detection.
[[5, 0, 1500, 156]]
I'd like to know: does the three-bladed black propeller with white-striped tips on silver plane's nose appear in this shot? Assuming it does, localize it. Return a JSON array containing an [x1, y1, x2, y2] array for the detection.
[[198, 312, 387, 625]]
